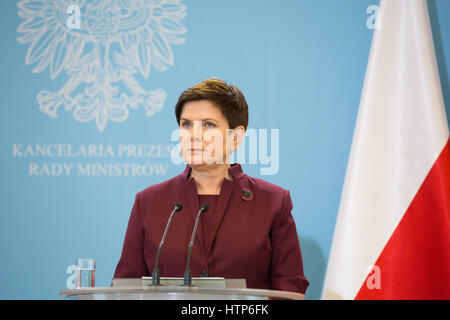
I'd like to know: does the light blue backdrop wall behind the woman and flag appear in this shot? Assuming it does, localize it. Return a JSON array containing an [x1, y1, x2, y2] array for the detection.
[[0, 0, 450, 299]]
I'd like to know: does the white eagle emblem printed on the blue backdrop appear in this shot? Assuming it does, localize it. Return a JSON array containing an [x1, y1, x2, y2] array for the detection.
[[17, 0, 187, 132]]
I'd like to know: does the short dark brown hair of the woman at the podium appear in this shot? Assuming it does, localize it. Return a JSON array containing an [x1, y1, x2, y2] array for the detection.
[[175, 78, 248, 129]]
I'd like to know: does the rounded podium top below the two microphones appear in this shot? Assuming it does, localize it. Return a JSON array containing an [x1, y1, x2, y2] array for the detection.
[[60, 286, 305, 300]]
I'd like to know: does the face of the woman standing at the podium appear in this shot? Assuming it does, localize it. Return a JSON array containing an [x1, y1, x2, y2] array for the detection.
[[180, 100, 244, 166]]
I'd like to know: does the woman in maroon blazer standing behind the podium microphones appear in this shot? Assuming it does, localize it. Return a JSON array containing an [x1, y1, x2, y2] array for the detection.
[[114, 79, 309, 293]]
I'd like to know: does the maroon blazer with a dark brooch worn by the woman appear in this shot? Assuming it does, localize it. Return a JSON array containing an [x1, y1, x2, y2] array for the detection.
[[114, 164, 309, 293]]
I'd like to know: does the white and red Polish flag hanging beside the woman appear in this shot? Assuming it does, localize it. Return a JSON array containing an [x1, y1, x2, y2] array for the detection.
[[322, 0, 450, 299]]
